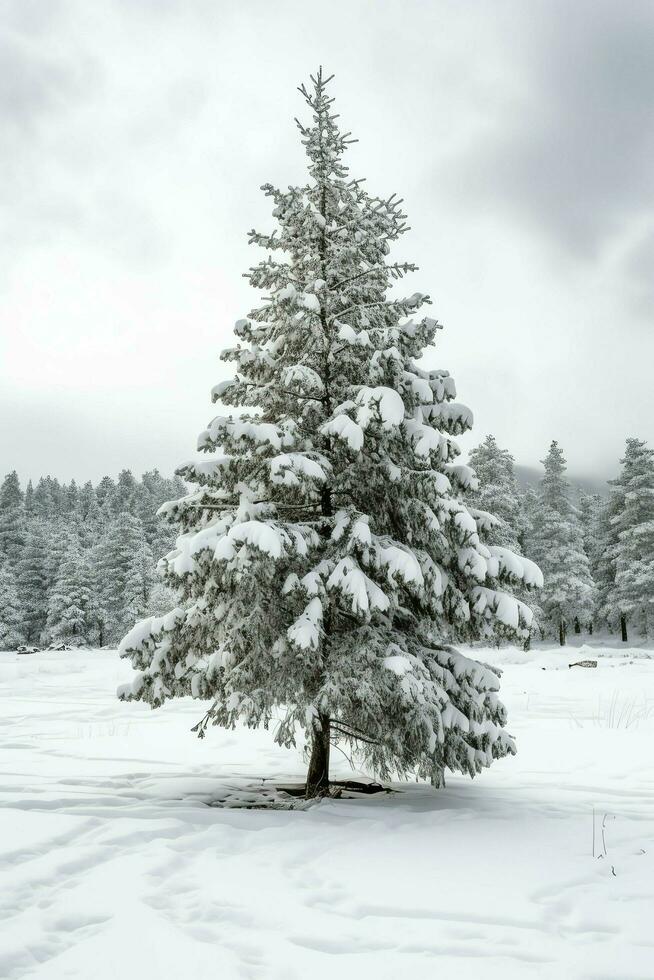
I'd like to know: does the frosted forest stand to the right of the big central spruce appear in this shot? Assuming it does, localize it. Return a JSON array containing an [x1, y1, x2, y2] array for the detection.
[[470, 436, 654, 644]]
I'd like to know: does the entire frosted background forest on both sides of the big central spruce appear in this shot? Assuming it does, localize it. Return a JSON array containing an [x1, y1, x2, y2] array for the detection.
[[0, 436, 654, 649]]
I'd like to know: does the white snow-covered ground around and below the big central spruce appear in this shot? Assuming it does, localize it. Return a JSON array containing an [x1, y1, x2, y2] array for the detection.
[[0, 648, 654, 980]]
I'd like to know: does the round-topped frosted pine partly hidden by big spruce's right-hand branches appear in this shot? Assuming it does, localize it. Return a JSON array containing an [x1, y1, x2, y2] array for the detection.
[[469, 435, 525, 554]]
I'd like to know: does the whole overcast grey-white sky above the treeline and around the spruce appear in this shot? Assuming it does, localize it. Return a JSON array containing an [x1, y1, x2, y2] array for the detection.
[[0, 0, 654, 481]]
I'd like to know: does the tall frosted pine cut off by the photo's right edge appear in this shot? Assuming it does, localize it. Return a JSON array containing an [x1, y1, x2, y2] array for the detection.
[[611, 439, 654, 640]]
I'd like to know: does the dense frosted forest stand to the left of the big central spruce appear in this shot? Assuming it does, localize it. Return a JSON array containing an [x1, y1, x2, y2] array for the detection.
[[0, 470, 186, 649]]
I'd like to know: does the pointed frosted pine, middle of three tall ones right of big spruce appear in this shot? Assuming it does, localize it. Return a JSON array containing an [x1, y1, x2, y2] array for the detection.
[[527, 440, 595, 646]]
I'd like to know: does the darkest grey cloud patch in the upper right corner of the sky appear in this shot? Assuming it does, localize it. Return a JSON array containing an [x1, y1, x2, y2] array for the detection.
[[448, 2, 654, 257]]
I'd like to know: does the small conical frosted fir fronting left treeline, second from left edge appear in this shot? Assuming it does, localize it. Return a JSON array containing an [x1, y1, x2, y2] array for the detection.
[[45, 540, 95, 646]]
